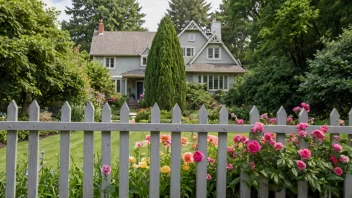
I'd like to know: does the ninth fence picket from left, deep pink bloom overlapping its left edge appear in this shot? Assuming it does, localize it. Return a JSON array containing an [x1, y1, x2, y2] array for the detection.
[[196, 105, 208, 198]]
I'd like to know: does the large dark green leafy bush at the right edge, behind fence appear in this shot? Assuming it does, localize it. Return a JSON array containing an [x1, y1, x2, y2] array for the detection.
[[300, 29, 352, 115]]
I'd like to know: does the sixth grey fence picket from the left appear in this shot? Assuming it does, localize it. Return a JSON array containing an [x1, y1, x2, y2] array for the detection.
[[119, 102, 130, 198]]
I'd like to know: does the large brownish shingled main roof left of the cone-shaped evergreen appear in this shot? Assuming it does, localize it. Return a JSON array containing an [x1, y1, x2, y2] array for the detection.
[[90, 31, 156, 56]]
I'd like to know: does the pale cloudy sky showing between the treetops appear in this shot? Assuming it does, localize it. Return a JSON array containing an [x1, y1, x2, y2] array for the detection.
[[42, 0, 222, 31]]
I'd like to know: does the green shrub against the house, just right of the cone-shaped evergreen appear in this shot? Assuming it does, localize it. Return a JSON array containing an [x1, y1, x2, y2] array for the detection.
[[186, 82, 215, 110]]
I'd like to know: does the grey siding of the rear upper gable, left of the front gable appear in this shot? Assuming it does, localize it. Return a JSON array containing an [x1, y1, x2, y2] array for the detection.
[[178, 30, 207, 64]]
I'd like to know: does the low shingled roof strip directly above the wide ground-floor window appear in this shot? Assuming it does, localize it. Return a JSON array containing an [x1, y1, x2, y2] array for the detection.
[[186, 63, 246, 73]]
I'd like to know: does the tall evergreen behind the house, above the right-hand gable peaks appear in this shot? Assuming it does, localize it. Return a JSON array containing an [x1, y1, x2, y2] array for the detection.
[[167, 0, 211, 32]]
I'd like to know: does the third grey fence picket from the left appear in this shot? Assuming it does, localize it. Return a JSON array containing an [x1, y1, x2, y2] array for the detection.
[[59, 101, 71, 198]]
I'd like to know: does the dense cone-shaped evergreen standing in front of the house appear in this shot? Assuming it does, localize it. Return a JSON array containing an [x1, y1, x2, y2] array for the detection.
[[145, 16, 186, 110]]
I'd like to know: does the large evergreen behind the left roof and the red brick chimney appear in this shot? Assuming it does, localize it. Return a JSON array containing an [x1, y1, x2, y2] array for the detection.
[[62, 0, 146, 51]]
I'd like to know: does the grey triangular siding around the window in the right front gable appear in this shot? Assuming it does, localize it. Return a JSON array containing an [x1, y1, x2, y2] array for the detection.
[[193, 44, 236, 64]]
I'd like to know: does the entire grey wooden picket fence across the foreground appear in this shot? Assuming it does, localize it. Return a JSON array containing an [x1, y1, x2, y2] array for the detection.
[[0, 101, 352, 198]]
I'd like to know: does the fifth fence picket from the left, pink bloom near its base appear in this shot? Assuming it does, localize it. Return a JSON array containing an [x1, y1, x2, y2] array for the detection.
[[100, 103, 111, 198]]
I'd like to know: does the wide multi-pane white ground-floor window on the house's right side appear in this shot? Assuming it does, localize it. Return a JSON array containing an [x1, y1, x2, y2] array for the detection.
[[198, 75, 229, 91]]
